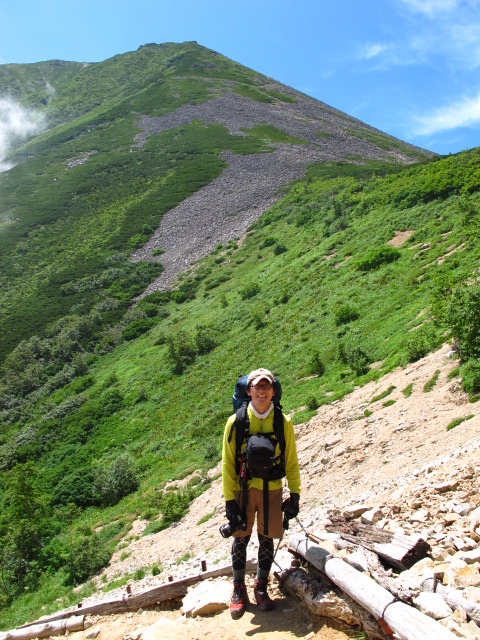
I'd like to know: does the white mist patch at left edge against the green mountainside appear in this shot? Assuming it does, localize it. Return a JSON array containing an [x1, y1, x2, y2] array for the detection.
[[0, 97, 45, 172]]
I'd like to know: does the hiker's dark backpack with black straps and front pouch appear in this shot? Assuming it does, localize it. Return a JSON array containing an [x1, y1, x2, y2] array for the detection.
[[228, 375, 286, 535]]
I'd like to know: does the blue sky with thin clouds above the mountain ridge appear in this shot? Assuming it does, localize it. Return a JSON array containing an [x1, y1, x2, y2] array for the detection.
[[0, 0, 480, 154]]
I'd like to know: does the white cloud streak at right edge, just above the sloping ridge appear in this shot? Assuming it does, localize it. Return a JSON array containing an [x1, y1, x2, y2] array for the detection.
[[415, 92, 480, 136]]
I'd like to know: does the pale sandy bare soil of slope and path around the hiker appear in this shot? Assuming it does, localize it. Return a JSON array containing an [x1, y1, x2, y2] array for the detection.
[[55, 345, 480, 640]]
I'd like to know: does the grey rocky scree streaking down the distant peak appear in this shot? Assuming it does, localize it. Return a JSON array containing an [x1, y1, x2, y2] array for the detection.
[[132, 83, 433, 294]]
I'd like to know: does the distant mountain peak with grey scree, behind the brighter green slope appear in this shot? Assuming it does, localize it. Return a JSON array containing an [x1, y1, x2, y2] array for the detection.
[[0, 42, 432, 353]]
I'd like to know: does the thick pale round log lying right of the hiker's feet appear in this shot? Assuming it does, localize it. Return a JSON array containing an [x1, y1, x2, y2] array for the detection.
[[288, 535, 456, 640]]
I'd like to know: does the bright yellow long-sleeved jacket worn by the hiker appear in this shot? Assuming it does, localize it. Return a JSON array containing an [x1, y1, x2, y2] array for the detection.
[[222, 405, 300, 501]]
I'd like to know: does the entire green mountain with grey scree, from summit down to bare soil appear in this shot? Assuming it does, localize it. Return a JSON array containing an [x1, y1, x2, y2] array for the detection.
[[0, 43, 480, 627]]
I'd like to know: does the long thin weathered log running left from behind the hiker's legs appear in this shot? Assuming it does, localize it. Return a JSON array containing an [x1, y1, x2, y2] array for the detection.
[[19, 561, 257, 640]]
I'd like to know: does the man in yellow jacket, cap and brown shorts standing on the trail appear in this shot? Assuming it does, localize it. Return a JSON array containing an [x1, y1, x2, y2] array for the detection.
[[221, 369, 300, 619]]
